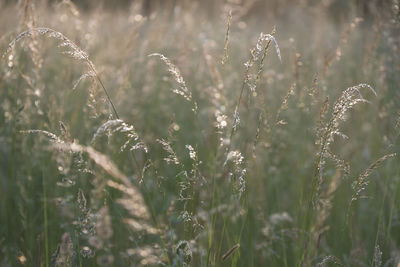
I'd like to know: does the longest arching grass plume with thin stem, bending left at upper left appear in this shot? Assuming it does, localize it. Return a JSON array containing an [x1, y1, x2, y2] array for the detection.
[[3, 27, 119, 119]]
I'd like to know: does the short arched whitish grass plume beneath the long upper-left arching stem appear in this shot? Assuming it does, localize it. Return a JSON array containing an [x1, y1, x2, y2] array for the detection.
[[91, 119, 148, 153]]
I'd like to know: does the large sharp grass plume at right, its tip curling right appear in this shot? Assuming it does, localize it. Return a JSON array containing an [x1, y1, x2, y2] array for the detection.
[[311, 84, 376, 204]]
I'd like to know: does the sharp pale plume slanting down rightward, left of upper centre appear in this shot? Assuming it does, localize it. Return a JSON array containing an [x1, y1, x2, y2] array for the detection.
[[149, 53, 197, 113]]
